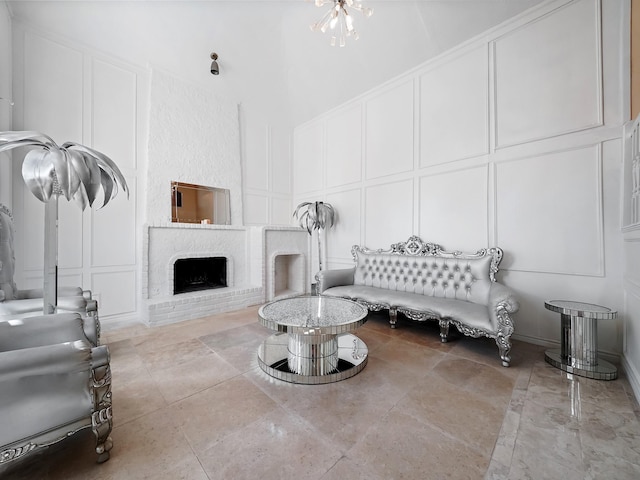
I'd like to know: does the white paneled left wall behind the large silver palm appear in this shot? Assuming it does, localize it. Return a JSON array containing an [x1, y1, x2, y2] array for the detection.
[[11, 22, 146, 324]]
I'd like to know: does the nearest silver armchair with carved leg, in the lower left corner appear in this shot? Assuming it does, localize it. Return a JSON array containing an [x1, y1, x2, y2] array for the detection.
[[0, 313, 113, 465]]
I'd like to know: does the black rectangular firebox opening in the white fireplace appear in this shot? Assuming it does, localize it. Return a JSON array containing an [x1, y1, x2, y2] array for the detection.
[[173, 257, 227, 295]]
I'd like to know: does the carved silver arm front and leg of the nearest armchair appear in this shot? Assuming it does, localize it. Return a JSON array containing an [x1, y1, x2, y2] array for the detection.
[[91, 356, 113, 463]]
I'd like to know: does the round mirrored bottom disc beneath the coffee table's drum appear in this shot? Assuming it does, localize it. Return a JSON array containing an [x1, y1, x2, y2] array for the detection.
[[258, 333, 369, 385]]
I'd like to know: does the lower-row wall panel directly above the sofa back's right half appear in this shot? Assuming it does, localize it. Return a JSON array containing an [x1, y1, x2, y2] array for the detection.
[[419, 166, 488, 252]]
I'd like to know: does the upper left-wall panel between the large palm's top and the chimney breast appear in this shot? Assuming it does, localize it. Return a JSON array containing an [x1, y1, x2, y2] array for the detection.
[[91, 60, 137, 169]]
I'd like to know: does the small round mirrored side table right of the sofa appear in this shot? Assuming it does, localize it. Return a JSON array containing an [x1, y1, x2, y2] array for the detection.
[[544, 300, 618, 380]]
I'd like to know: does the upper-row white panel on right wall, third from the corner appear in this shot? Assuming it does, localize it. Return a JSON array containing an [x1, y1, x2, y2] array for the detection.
[[365, 81, 414, 179]]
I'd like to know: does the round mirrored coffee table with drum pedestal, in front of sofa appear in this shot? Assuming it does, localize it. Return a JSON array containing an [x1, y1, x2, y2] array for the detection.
[[258, 295, 369, 385]]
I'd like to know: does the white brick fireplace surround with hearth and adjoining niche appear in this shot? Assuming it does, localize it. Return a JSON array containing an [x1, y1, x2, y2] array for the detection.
[[142, 223, 310, 325]]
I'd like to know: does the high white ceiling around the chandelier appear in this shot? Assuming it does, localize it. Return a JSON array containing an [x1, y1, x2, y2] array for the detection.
[[7, 0, 543, 125]]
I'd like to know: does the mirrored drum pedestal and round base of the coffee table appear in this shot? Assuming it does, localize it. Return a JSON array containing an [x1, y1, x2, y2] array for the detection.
[[258, 333, 369, 385]]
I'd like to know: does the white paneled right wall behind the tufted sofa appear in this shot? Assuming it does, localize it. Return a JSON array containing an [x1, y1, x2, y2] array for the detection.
[[294, 0, 637, 360]]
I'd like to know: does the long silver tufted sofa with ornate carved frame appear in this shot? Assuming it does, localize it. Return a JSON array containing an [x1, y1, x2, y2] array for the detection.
[[316, 236, 519, 367]]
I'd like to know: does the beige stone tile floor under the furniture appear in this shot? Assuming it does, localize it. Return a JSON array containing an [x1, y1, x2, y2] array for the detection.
[[0, 308, 640, 480]]
